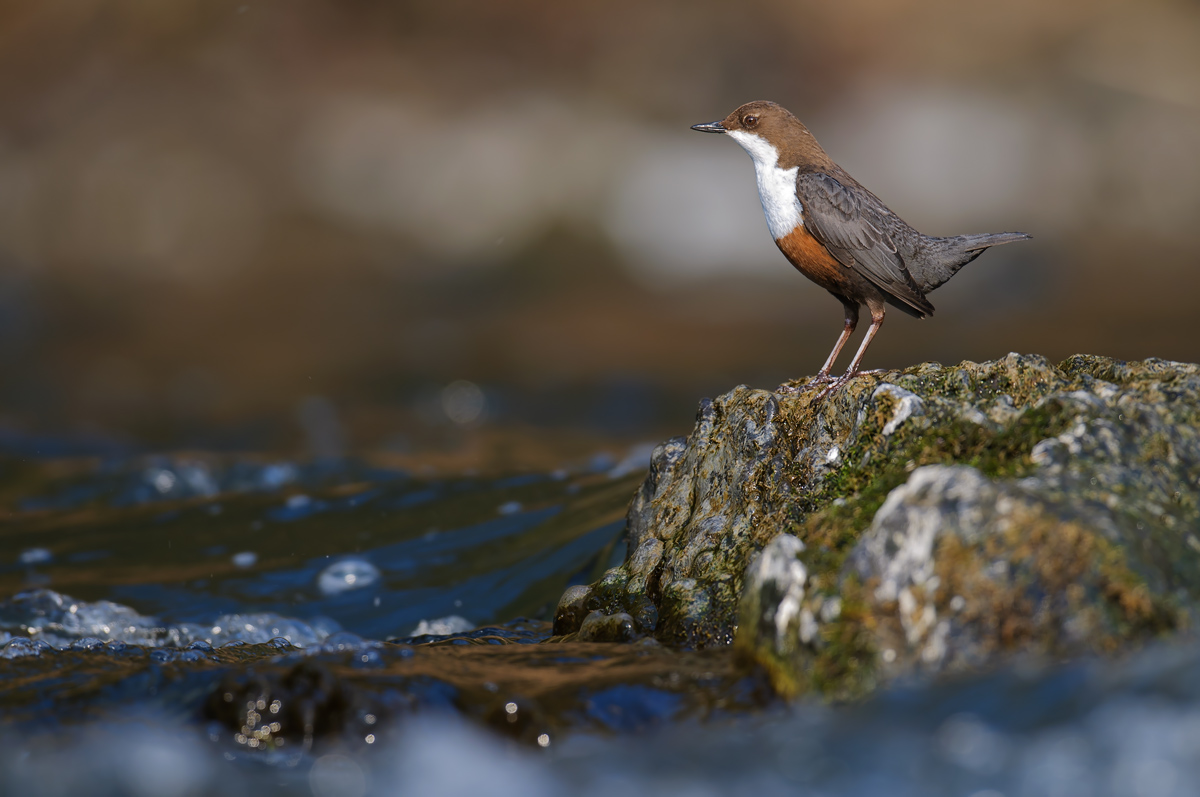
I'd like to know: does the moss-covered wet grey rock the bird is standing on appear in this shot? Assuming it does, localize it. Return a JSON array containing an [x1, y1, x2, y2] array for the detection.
[[556, 354, 1200, 696]]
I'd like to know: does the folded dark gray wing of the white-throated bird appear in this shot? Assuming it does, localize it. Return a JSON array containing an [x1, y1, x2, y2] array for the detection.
[[796, 172, 934, 314]]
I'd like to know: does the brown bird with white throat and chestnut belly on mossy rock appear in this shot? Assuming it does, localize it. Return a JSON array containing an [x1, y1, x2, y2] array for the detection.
[[691, 101, 1032, 395]]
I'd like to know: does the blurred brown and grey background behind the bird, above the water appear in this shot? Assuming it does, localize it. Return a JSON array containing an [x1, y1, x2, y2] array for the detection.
[[0, 0, 1200, 461]]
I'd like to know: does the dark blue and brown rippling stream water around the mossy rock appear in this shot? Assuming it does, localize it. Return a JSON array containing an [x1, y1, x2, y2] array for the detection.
[[0, 444, 1200, 797]]
